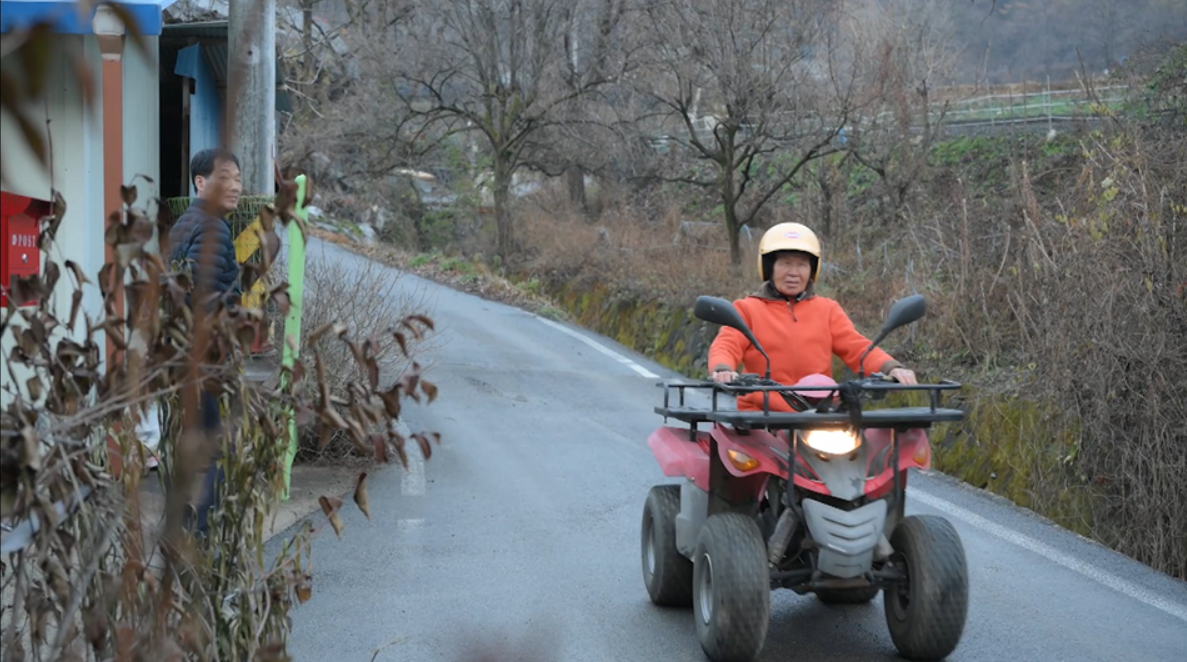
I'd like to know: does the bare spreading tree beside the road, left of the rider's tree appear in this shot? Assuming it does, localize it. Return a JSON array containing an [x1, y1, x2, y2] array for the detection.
[[393, 0, 610, 257]]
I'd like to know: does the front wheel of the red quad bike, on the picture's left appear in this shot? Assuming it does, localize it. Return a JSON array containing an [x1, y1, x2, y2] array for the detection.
[[692, 513, 770, 662]]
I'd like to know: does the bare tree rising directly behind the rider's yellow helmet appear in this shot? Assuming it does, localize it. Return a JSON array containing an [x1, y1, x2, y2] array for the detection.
[[635, 0, 852, 267]]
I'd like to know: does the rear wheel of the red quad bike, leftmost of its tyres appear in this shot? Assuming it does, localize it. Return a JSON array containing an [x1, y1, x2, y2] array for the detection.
[[641, 485, 692, 606]]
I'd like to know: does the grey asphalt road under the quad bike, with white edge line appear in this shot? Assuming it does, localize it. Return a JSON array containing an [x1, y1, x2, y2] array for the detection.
[[280, 242, 1187, 662]]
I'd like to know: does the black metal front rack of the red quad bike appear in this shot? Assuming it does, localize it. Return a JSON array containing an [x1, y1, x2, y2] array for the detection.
[[655, 380, 965, 429]]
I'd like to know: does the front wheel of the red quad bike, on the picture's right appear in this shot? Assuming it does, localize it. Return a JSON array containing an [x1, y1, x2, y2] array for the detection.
[[882, 515, 969, 660]]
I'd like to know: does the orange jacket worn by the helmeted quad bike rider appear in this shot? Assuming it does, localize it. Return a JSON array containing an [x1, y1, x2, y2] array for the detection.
[[709, 284, 902, 412]]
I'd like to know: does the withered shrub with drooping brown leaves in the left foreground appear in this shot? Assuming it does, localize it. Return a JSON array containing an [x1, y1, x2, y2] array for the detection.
[[0, 9, 437, 661]]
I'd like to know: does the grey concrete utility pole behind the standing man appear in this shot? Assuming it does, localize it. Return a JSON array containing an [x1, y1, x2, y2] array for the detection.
[[223, 0, 277, 196]]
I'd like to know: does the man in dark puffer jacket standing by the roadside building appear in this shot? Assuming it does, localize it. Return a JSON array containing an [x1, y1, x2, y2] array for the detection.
[[169, 148, 243, 536]]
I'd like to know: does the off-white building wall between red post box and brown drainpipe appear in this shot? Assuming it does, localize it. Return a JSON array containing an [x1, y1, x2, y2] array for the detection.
[[0, 34, 104, 403]]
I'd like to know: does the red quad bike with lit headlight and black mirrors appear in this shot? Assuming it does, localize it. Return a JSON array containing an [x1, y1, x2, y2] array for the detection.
[[642, 295, 969, 662]]
